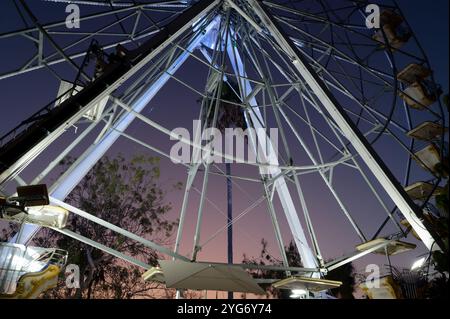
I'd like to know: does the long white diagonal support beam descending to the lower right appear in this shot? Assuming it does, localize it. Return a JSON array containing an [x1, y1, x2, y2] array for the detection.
[[248, 0, 445, 255]]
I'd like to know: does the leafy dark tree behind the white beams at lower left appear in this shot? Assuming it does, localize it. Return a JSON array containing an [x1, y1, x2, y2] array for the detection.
[[34, 155, 180, 299]]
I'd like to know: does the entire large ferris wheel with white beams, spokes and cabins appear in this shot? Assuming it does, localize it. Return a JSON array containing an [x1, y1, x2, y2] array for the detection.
[[0, 0, 448, 300]]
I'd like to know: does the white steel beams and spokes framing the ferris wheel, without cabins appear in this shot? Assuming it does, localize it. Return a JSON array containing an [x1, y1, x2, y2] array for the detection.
[[0, 0, 443, 286]]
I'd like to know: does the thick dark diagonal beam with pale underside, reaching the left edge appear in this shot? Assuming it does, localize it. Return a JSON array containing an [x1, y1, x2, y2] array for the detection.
[[0, 0, 219, 185]]
